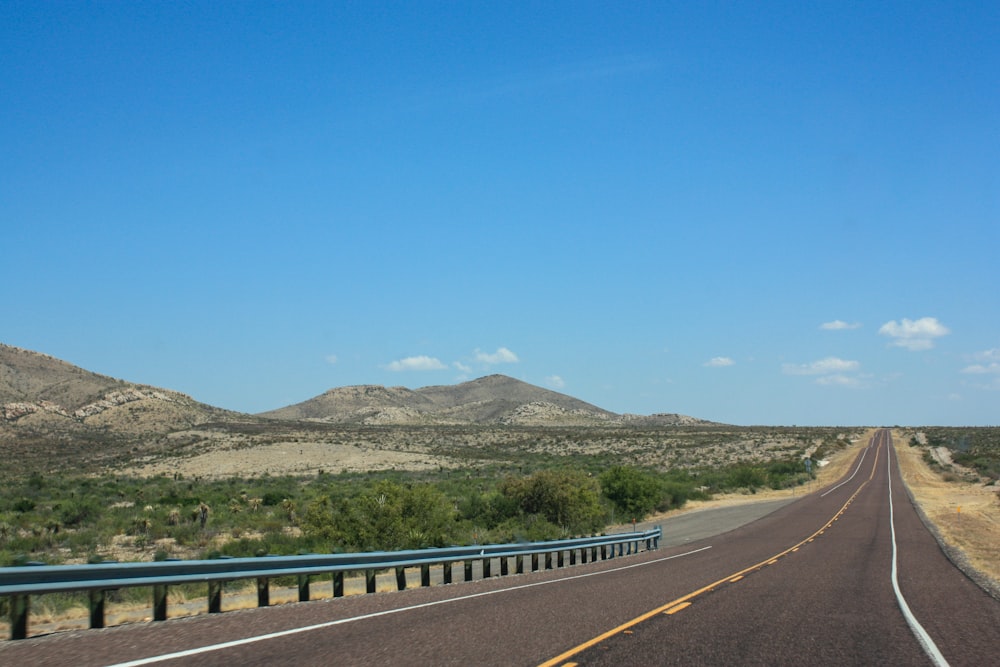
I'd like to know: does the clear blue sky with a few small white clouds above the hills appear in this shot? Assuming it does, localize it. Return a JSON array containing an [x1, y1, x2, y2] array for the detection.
[[0, 1, 1000, 425]]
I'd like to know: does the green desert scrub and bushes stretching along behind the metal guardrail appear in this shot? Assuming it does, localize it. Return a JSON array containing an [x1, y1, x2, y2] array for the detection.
[[0, 432, 848, 566]]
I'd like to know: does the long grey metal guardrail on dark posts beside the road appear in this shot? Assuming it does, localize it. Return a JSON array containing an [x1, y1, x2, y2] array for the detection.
[[0, 527, 662, 639]]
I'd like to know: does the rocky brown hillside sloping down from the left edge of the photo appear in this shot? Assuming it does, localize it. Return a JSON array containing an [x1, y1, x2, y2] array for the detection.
[[0, 343, 237, 436]]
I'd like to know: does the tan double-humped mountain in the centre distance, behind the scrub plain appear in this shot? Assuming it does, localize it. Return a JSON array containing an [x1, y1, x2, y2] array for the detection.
[[258, 375, 708, 426]]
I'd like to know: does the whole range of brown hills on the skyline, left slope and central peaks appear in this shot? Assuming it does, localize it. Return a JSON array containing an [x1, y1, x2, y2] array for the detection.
[[0, 343, 709, 444]]
